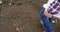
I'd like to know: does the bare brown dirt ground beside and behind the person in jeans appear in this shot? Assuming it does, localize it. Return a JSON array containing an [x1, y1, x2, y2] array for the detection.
[[0, 0, 60, 32]]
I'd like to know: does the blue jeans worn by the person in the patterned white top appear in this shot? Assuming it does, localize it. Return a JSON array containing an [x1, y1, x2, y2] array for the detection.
[[40, 8, 54, 32]]
